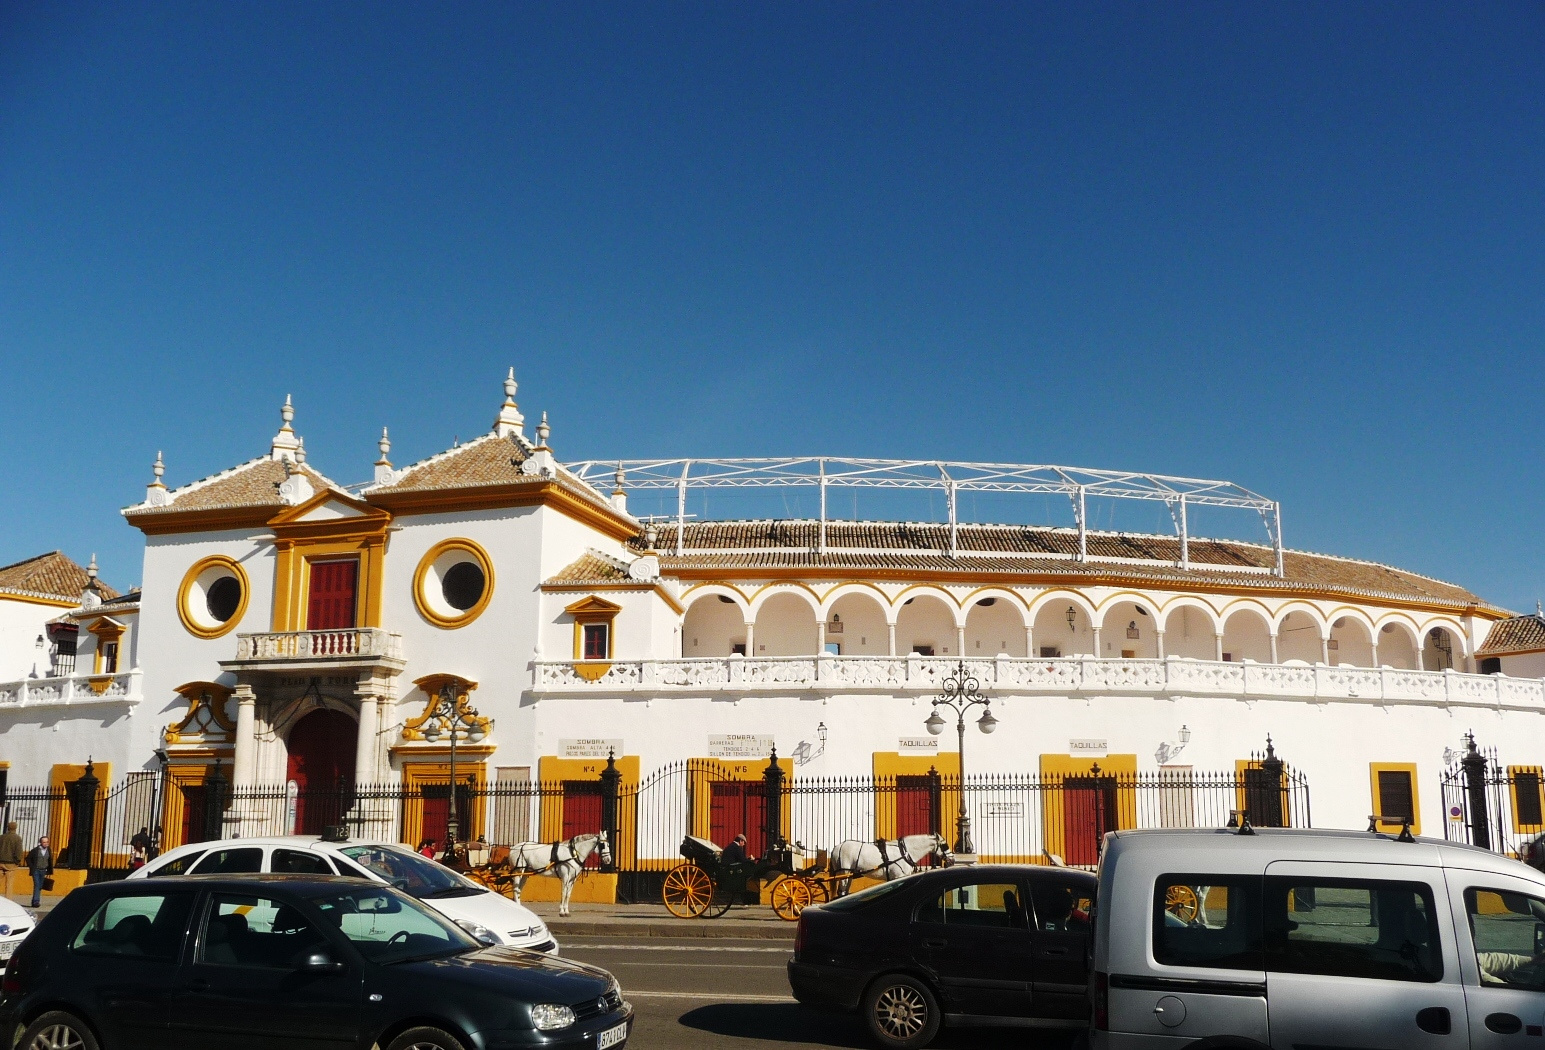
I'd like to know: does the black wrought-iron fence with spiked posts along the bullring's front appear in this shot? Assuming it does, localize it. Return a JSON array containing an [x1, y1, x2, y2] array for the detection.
[[0, 750, 1316, 900]]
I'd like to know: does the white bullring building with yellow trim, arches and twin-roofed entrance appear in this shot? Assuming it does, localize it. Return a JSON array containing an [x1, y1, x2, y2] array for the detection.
[[0, 372, 1545, 883]]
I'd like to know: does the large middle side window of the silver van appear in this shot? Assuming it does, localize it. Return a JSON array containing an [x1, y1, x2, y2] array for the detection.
[[1265, 876, 1443, 981]]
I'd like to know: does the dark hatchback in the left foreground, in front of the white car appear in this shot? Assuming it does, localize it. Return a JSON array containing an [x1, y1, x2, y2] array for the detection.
[[0, 876, 633, 1050]]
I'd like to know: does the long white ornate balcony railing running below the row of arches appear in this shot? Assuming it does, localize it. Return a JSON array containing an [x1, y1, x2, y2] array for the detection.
[[536, 656, 1545, 707]]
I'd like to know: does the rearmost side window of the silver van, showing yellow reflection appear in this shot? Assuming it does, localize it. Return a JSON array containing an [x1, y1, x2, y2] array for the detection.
[[1153, 876, 1265, 970]]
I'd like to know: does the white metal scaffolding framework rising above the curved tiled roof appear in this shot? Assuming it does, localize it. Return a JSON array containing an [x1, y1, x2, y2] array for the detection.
[[564, 456, 1282, 576]]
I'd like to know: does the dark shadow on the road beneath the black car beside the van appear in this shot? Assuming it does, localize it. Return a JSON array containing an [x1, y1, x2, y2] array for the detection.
[[680, 1002, 1074, 1050]]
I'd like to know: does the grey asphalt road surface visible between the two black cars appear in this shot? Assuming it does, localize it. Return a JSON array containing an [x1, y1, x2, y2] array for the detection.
[[562, 937, 1071, 1050]]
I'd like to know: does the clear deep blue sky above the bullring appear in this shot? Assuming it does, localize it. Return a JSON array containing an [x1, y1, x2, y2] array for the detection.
[[0, 3, 1545, 610]]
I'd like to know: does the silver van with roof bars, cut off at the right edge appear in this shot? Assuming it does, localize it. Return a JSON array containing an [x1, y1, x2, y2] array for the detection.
[[1089, 826, 1545, 1050]]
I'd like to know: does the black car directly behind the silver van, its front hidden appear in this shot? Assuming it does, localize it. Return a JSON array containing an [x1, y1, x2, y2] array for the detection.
[[788, 865, 1097, 1050]]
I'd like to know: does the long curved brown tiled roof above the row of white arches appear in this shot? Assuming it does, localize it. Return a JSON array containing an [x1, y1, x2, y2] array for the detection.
[[633, 520, 1486, 607]]
